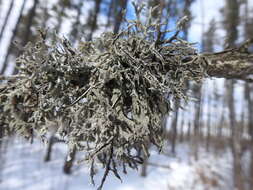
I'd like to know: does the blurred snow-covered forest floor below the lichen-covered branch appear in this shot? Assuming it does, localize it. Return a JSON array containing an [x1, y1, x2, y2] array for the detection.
[[0, 139, 233, 190]]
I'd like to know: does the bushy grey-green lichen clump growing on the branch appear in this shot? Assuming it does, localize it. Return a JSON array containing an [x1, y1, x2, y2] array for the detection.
[[0, 4, 206, 188]]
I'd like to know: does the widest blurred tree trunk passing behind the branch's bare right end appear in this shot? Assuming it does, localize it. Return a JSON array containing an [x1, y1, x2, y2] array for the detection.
[[224, 0, 245, 190]]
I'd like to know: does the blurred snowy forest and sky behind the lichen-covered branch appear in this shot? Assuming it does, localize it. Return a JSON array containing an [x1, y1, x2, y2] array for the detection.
[[0, 0, 253, 190]]
